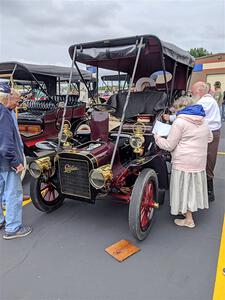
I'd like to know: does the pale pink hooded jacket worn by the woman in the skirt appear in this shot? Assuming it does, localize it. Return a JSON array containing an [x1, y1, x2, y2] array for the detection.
[[155, 114, 213, 172]]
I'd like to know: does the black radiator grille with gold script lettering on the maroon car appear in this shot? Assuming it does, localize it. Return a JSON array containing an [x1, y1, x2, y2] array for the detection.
[[59, 158, 91, 199]]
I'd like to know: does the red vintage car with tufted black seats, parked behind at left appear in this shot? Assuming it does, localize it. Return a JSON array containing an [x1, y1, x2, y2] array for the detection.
[[0, 62, 93, 157]]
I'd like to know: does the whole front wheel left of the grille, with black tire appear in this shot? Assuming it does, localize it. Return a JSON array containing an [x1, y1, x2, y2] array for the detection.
[[30, 176, 64, 212]]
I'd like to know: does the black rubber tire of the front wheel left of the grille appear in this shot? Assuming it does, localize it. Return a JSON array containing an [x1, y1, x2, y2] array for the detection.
[[30, 177, 64, 212]]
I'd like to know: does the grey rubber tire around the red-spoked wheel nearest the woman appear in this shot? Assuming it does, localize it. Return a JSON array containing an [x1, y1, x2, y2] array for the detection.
[[129, 169, 158, 241]]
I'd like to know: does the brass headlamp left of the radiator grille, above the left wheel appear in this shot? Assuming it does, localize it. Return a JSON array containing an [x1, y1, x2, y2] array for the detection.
[[28, 157, 52, 179]]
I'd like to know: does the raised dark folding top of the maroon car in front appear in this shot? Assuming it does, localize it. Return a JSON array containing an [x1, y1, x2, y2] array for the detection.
[[69, 35, 195, 90]]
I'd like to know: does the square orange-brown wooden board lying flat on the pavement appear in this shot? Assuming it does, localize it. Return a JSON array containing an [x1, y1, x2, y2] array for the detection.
[[105, 240, 141, 262]]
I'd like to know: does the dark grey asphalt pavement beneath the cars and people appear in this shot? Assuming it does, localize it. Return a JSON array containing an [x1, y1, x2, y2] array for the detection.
[[0, 126, 225, 300]]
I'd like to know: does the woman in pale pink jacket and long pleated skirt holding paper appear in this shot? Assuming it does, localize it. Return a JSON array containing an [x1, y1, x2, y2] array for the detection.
[[155, 105, 213, 228]]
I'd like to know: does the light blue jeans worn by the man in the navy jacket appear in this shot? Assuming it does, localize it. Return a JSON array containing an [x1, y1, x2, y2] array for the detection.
[[0, 171, 23, 232]]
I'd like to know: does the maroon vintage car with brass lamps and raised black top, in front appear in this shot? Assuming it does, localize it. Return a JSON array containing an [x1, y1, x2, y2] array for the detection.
[[29, 35, 194, 240]]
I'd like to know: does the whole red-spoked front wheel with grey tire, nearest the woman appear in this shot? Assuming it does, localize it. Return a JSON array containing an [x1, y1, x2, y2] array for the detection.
[[129, 169, 158, 240]]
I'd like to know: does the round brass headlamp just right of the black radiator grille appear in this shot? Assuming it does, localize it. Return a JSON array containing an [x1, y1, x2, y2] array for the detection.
[[89, 164, 113, 189]]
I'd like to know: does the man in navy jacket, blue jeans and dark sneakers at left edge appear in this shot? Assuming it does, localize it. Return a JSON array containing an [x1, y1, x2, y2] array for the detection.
[[0, 84, 32, 240]]
